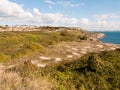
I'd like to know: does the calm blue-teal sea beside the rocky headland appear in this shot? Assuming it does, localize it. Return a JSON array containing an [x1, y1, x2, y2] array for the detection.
[[100, 32, 120, 44]]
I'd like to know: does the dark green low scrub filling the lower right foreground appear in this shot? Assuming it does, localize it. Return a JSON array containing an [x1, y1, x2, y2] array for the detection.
[[39, 50, 120, 90]]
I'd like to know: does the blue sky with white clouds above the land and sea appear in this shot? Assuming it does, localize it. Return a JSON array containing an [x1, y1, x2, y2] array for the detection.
[[0, 0, 120, 31]]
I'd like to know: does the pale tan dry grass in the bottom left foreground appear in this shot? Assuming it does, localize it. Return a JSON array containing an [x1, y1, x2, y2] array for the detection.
[[0, 72, 53, 90]]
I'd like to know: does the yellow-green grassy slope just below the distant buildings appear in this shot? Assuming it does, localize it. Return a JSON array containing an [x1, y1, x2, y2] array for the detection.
[[0, 30, 87, 62]]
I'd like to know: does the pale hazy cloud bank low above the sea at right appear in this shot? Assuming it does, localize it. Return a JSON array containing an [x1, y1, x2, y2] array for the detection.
[[87, 13, 120, 30]]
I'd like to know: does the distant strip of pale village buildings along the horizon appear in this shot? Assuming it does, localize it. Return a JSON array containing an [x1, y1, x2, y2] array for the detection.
[[0, 25, 82, 32]]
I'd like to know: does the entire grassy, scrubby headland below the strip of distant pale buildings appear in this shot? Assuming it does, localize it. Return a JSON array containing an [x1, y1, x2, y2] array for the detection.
[[0, 27, 120, 90]]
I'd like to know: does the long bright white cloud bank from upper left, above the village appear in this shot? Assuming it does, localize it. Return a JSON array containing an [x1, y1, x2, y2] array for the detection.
[[0, 0, 87, 26]]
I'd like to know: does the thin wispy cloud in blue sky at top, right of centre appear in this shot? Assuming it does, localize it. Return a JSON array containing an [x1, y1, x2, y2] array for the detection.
[[57, 1, 85, 7]]
